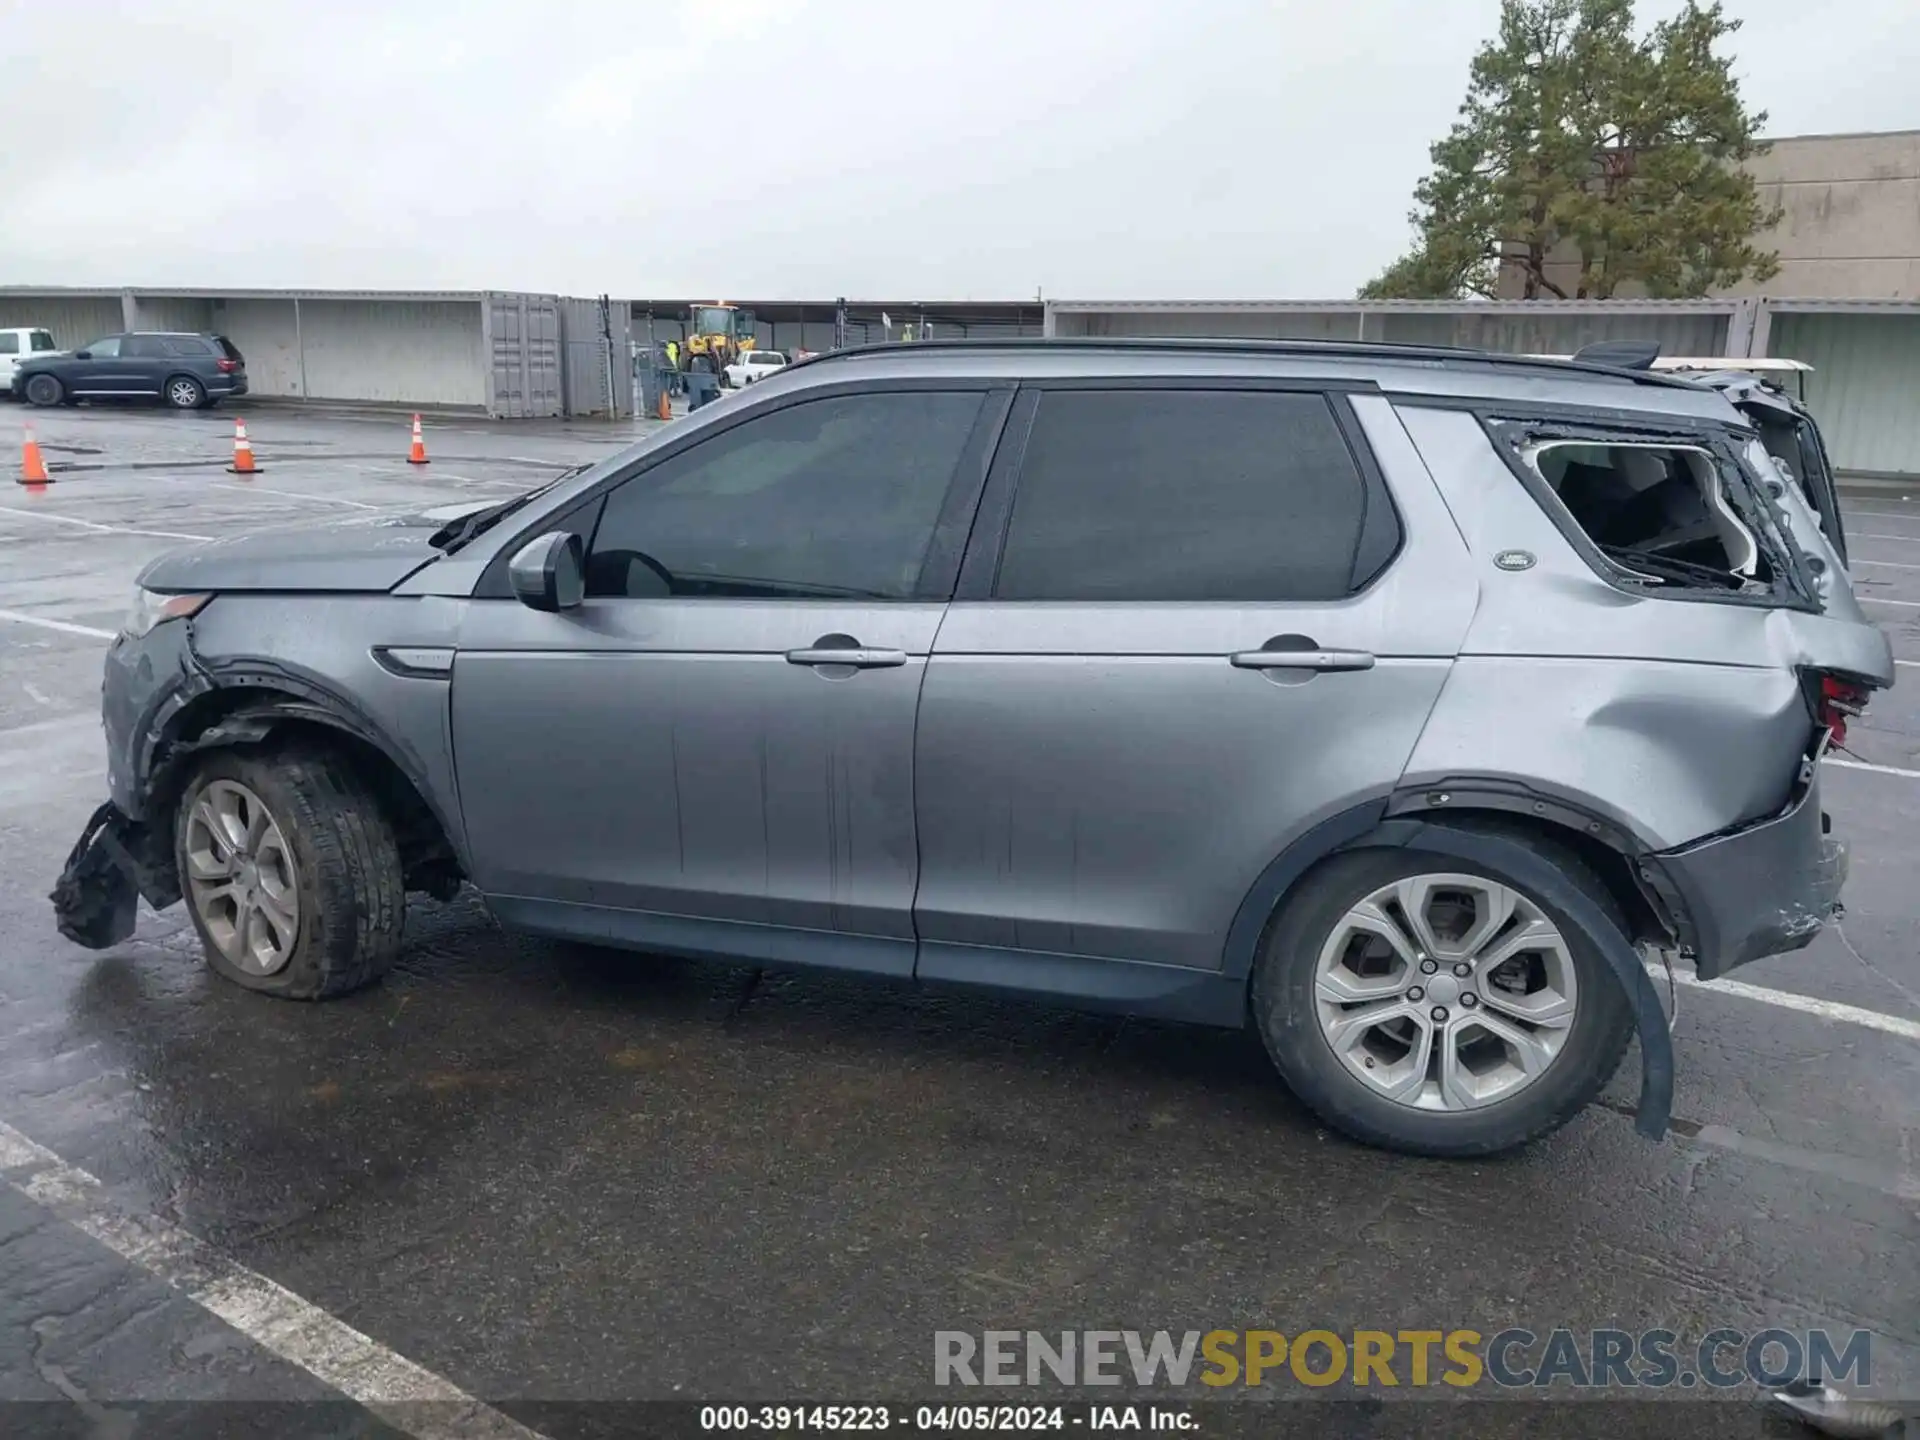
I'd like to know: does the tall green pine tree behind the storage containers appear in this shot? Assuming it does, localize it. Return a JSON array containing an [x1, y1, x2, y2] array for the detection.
[[1361, 0, 1780, 300]]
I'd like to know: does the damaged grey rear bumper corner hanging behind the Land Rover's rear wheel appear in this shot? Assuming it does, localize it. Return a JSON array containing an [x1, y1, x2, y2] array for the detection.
[[1649, 756, 1847, 979]]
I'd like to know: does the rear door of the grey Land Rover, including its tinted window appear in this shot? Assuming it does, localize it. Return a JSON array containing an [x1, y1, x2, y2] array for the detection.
[[914, 382, 1476, 983]]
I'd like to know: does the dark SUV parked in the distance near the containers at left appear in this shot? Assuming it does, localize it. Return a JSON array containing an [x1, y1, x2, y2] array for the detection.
[[13, 330, 246, 411]]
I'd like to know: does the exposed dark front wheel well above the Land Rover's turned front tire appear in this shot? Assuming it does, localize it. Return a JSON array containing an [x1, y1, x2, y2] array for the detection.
[[148, 685, 463, 899]]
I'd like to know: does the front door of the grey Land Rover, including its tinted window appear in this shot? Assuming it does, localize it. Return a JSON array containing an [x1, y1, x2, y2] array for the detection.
[[453, 390, 1004, 973]]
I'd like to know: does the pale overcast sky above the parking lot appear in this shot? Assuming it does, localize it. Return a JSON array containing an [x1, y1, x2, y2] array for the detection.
[[0, 0, 1920, 300]]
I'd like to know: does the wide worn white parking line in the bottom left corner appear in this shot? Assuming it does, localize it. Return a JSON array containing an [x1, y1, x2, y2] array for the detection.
[[0, 1121, 541, 1440]]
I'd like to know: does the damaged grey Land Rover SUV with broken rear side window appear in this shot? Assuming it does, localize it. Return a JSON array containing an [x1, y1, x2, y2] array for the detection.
[[54, 340, 1893, 1156]]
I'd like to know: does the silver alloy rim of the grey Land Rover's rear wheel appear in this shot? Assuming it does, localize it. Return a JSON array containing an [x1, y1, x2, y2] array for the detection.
[[1313, 874, 1580, 1110]]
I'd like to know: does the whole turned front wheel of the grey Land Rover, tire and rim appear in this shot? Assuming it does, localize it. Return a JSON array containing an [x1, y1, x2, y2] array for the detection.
[[175, 747, 407, 1000]]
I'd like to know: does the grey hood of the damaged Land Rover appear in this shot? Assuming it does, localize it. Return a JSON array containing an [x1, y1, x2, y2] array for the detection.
[[140, 499, 497, 593]]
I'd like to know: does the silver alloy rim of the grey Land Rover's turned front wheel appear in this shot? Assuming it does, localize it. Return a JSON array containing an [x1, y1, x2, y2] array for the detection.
[[182, 780, 300, 975]]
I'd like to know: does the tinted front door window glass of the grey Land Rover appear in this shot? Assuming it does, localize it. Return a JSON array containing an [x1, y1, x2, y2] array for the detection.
[[588, 392, 985, 599]]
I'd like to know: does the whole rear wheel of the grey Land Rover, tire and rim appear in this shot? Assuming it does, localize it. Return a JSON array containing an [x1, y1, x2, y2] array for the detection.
[[1254, 847, 1632, 1156]]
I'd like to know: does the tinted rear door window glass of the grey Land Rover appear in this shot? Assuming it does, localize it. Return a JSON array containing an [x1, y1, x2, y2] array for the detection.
[[993, 390, 1398, 603]]
